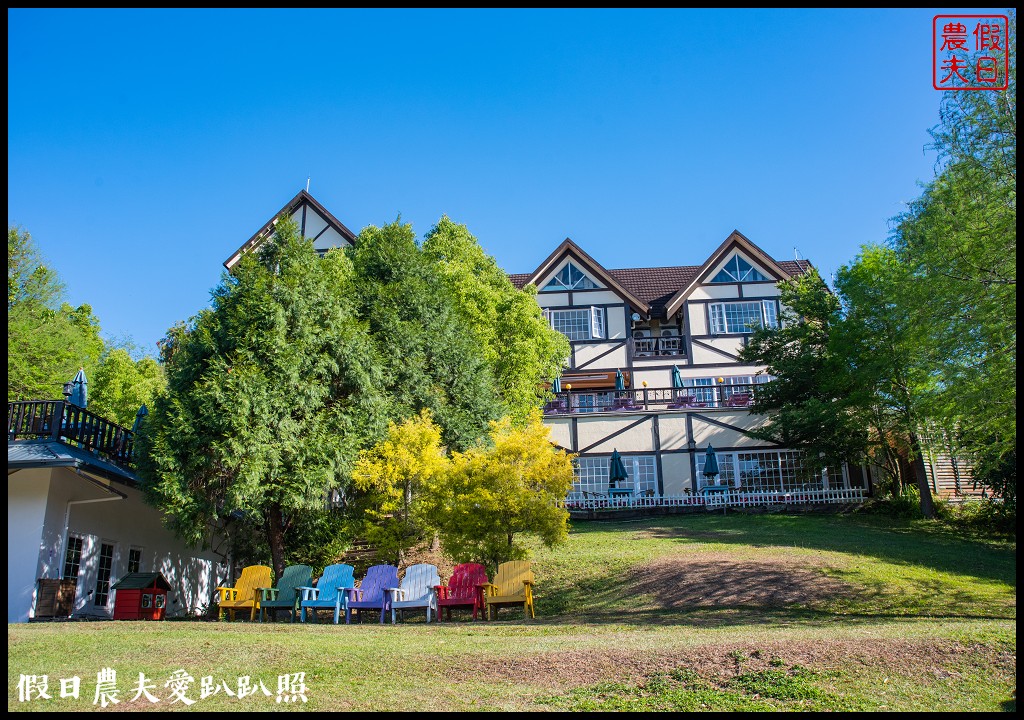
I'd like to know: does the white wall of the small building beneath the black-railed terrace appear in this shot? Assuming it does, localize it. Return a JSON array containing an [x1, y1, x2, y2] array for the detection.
[[8, 468, 223, 622]]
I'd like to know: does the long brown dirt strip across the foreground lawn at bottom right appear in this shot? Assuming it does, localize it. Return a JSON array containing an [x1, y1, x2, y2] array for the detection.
[[443, 639, 1017, 688]]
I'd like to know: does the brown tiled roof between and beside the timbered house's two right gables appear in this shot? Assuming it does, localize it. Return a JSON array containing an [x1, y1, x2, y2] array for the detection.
[[509, 231, 811, 316]]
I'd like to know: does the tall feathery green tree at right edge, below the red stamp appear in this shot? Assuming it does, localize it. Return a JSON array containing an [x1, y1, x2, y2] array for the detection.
[[890, 15, 1017, 496]]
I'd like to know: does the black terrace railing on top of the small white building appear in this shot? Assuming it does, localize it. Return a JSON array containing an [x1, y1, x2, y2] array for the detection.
[[7, 400, 135, 468]]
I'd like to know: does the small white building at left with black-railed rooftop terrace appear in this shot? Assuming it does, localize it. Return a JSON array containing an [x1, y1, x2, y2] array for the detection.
[[7, 400, 225, 623]]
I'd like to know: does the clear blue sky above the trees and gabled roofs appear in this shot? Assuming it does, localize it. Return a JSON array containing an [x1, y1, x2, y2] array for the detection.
[[7, 9, 1005, 351]]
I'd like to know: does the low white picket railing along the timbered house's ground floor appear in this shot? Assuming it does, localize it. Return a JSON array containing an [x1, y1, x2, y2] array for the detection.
[[564, 488, 866, 510]]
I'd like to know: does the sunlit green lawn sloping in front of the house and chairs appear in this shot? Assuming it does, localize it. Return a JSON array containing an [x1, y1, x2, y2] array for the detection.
[[7, 514, 1017, 712]]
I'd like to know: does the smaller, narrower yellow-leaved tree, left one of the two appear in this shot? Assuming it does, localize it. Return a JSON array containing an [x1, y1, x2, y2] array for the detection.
[[352, 410, 449, 562]]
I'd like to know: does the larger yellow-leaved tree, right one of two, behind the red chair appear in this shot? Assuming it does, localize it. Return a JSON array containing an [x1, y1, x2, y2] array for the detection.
[[418, 411, 572, 570]]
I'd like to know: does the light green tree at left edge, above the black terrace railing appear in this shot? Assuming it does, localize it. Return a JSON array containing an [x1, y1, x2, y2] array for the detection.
[[7, 227, 103, 400]]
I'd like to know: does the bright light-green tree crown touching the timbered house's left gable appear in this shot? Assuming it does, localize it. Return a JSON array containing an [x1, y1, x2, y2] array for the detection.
[[423, 215, 569, 420]]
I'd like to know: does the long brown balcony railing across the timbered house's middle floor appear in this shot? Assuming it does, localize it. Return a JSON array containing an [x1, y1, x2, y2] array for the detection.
[[544, 384, 758, 415]]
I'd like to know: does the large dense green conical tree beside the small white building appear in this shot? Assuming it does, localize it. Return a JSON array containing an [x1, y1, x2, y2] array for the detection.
[[139, 222, 386, 574]]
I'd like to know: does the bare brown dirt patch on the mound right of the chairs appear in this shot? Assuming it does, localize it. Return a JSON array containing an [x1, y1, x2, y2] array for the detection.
[[628, 553, 855, 609]]
